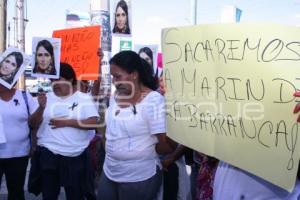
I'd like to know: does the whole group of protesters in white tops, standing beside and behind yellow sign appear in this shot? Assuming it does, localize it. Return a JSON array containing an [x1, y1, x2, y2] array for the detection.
[[0, 45, 300, 200]]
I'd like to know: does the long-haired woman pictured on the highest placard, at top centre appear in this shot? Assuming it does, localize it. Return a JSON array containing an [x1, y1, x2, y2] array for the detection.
[[113, 0, 130, 34]]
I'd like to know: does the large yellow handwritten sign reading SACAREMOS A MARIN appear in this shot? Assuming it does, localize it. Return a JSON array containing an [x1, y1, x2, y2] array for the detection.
[[162, 24, 300, 191]]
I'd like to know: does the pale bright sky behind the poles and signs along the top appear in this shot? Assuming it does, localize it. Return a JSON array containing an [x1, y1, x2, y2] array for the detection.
[[7, 0, 300, 54]]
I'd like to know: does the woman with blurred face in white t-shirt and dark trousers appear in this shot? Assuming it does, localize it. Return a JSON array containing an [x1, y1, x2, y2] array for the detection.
[[30, 63, 99, 200]]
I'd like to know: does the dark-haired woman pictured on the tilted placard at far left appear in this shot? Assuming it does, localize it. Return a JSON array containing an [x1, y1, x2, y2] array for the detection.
[[0, 51, 23, 84]]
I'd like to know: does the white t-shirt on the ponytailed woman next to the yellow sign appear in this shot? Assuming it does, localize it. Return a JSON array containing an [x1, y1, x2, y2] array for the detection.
[[103, 91, 166, 182]]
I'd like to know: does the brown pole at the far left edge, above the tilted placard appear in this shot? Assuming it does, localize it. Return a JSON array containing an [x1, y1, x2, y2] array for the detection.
[[0, 0, 7, 53]]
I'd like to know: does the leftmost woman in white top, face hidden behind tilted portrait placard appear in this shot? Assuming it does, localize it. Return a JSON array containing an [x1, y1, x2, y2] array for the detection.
[[0, 85, 37, 200]]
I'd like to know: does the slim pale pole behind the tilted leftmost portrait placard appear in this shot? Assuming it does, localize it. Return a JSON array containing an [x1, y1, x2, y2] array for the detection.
[[15, 0, 25, 90]]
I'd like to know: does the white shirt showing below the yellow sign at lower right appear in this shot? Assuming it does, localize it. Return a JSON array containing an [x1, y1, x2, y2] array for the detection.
[[213, 162, 300, 200]]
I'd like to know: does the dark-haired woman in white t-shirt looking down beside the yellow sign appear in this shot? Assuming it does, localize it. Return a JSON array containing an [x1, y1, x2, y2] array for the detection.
[[98, 51, 175, 200]]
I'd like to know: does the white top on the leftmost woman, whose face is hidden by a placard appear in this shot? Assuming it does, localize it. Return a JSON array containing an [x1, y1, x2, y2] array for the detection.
[[0, 90, 38, 158]]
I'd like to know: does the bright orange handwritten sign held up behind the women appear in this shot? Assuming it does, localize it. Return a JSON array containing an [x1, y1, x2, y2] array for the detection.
[[53, 26, 101, 80]]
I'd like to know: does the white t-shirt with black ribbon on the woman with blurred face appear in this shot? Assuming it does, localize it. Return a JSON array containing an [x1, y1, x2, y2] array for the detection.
[[37, 91, 99, 157]]
